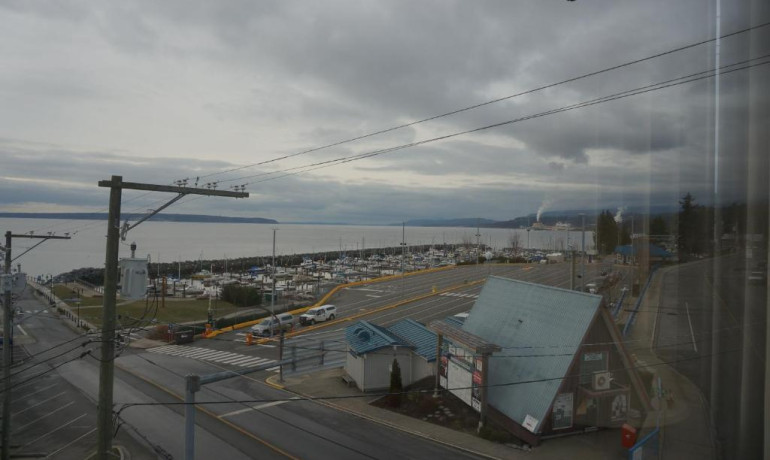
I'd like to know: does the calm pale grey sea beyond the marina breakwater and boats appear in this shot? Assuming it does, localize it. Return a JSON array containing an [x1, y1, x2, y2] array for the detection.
[[0, 218, 593, 276]]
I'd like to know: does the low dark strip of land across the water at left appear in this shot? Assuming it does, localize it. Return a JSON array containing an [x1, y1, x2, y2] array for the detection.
[[0, 212, 278, 224]]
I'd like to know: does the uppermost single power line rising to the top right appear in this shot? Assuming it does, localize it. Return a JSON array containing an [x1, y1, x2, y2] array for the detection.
[[192, 22, 770, 182]]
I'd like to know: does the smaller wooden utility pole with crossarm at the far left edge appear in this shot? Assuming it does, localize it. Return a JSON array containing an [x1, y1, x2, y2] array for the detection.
[[2, 232, 70, 460]]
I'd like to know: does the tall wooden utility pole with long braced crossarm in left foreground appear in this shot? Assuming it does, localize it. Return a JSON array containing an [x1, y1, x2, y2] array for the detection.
[[96, 176, 249, 460]]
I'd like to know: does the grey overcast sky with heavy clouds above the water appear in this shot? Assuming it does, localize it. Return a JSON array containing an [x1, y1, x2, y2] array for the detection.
[[0, 0, 770, 224]]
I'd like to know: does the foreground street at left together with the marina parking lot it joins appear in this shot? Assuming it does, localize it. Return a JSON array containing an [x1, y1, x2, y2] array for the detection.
[[6, 264, 628, 459]]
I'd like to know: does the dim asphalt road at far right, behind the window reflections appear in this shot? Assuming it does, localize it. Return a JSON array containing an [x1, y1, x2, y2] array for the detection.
[[656, 254, 767, 458]]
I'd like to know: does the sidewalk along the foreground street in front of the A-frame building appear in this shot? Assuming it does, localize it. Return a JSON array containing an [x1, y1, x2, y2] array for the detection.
[[266, 368, 624, 460]]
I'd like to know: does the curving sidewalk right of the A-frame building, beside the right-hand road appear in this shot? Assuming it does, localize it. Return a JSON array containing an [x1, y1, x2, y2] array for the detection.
[[625, 266, 715, 460]]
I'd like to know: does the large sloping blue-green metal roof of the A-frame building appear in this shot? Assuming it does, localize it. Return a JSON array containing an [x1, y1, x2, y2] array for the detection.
[[462, 276, 602, 433]]
